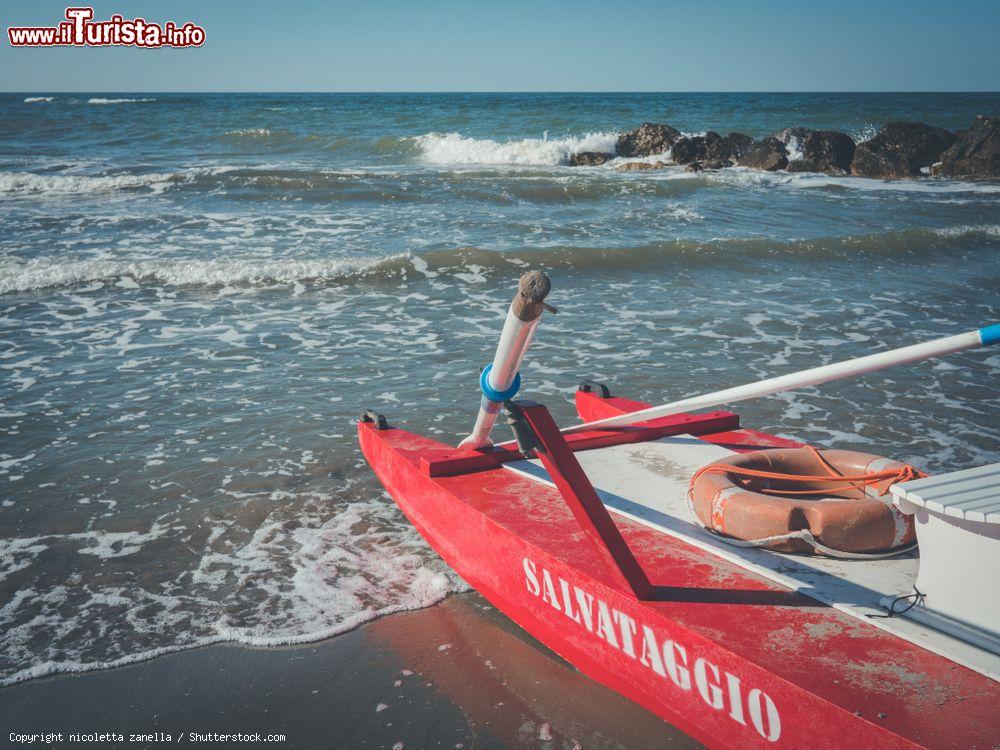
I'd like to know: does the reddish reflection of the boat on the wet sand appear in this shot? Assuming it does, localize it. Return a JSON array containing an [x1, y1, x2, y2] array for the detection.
[[365, 595, 701, 748]]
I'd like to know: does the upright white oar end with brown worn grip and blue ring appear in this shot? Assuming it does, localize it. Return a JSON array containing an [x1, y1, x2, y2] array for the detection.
[[458, 271, 555, 448]]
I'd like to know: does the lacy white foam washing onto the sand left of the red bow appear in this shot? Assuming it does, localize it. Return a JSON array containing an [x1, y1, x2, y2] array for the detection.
[[0, 492, 468, 686]]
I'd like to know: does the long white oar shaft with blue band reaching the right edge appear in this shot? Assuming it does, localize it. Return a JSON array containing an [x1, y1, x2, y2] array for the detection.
[[562, 323, 1000, 433]]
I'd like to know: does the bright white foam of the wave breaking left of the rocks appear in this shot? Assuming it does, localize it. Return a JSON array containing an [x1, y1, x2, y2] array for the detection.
[[415, 133, 618, 166]]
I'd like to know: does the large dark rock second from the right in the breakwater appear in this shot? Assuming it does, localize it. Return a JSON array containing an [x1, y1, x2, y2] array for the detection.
[[851, 122, 956, 179]]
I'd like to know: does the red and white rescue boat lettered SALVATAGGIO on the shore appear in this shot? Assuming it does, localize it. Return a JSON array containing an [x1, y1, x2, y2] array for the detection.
[[358, 274, 1000, 748]]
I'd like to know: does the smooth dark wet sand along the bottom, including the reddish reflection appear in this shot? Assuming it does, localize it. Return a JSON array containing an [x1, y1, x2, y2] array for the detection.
[[0, 593, 700, 750]]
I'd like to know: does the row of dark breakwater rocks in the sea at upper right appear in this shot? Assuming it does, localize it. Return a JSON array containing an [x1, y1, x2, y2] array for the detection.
[[569, 115, 1000, 179]]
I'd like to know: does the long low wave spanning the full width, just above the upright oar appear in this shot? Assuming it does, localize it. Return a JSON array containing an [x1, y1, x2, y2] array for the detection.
[[0, 224, 1000, 294]]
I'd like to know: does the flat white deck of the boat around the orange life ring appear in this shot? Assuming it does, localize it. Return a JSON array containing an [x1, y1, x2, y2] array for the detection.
[[505, 435, 1000, 680]]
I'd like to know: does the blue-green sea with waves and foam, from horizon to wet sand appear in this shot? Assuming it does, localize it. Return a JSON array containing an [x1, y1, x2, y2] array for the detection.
[[0, 92, 1000, 684]]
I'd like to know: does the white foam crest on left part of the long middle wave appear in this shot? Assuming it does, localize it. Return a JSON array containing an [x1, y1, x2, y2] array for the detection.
[[0, 254, 409, 294]]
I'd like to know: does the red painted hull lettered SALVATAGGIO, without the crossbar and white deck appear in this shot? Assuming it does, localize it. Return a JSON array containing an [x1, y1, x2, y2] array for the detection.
[[358, 394, 1000, 748]]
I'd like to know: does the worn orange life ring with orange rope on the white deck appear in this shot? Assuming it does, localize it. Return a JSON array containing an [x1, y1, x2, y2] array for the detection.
[[688, 448, 921, 553]]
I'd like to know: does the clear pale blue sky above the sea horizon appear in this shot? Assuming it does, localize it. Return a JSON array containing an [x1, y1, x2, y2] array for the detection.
[[0, 0, 1000, 92]]
